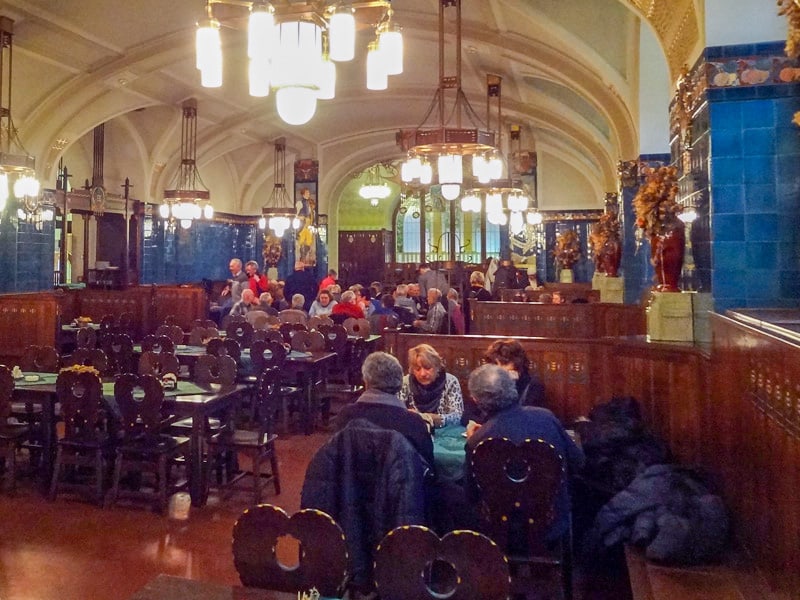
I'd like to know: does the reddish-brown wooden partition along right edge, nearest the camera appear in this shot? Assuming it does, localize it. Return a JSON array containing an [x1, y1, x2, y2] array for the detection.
[[700, 314, 800, 598]]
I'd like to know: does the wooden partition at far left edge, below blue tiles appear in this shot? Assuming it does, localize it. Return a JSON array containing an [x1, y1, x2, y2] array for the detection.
[[0, 292, 58, 366]]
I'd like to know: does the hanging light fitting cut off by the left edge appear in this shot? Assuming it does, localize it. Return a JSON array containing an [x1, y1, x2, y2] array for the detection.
[[0, 16, 39, 211]]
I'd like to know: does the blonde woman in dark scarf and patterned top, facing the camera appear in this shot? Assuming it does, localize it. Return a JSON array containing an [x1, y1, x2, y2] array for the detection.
[[400, 344, 464, 427]]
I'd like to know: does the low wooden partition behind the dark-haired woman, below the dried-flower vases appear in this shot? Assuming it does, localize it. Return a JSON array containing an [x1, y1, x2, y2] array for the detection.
[[470, 302, 647, 339]]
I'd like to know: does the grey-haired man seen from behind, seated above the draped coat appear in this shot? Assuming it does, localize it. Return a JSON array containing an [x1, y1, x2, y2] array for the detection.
[[333, 352, 433, 466]]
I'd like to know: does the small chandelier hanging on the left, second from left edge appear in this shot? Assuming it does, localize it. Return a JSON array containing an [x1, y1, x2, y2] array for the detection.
[[159, 98, 214, 229]]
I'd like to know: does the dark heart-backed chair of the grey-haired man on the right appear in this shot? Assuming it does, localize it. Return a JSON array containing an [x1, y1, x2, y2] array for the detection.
[[472, 438, 572, 600]]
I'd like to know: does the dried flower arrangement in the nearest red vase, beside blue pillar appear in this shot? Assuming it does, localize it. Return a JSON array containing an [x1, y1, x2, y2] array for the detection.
[[633, 167, 683, 237]]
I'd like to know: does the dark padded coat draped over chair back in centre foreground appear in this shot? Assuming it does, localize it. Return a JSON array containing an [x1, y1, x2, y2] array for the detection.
[[300, 419, 426, 586]]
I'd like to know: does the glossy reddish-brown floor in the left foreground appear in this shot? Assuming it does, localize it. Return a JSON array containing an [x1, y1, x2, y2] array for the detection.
[[0, 433, 630, 600]]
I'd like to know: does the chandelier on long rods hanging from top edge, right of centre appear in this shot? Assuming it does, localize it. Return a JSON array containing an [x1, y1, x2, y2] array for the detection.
[[397, 0, 503, 200]]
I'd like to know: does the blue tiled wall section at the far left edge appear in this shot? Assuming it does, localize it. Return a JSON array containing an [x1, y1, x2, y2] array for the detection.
[[0, 212, 55, 292]]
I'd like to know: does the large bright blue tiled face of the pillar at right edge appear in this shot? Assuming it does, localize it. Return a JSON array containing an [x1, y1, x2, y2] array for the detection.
[[707, 90, 800, 312]]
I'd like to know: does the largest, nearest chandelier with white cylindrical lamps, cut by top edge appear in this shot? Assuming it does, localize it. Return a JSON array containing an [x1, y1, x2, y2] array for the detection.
[[196, 0, 403, 125]]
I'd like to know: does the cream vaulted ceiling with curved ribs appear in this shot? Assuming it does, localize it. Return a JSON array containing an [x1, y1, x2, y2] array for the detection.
[[0, 0, 702, 220]]
